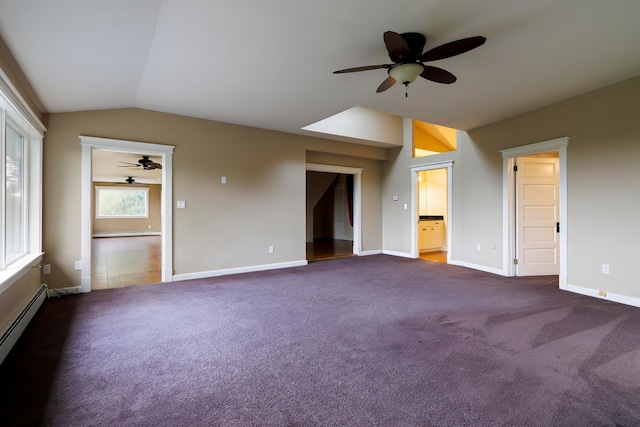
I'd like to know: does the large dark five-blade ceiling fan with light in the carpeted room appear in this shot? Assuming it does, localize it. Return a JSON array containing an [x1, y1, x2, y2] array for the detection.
[[333, 31, 487, 96]]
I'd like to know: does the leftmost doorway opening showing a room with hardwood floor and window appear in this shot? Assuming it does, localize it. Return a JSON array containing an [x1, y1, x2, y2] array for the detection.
[[91, 149, 162, 290]]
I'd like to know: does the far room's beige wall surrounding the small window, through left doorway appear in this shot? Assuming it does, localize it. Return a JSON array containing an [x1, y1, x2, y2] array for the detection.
[[91, 182, 162, 234]]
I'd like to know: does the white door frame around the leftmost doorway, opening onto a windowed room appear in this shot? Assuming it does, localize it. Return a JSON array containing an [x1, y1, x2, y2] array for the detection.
[[79, 135, 175, 292]]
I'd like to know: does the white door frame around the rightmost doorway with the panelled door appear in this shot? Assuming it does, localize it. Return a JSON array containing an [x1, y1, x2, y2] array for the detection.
[[500, 137, 569, 289]]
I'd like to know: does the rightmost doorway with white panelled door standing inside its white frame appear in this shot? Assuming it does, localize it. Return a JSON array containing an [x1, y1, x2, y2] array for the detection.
[[502, 138, 568, 288]]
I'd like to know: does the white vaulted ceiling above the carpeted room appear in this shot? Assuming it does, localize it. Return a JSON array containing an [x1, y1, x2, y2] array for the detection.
[[0, 0, 640, 143]]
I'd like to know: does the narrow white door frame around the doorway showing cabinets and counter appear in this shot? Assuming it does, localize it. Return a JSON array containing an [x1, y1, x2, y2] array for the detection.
[[410, 161, 453, 264]]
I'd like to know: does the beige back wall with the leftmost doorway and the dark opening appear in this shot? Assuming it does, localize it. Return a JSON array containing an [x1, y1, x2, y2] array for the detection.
[[43, 109, 387, 287]]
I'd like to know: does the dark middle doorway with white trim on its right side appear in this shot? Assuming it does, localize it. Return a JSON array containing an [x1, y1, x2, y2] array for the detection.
[[306, 164, 362, 261]]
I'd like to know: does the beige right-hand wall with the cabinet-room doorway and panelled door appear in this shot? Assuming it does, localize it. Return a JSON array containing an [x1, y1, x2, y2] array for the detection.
[[382, 73, 640, 298]]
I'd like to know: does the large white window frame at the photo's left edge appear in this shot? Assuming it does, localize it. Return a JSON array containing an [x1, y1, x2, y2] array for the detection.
[[0, 69, 46, 294]]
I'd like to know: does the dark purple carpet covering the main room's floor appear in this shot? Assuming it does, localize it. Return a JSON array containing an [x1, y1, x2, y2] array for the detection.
[[0, 255, 640, 426]]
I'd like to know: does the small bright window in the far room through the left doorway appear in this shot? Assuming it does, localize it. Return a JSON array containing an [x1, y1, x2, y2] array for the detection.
[[96, 187, 149, 218]]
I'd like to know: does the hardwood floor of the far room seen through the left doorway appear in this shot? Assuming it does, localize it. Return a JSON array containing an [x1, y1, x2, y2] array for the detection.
[[91, 236, 162, 290]]
